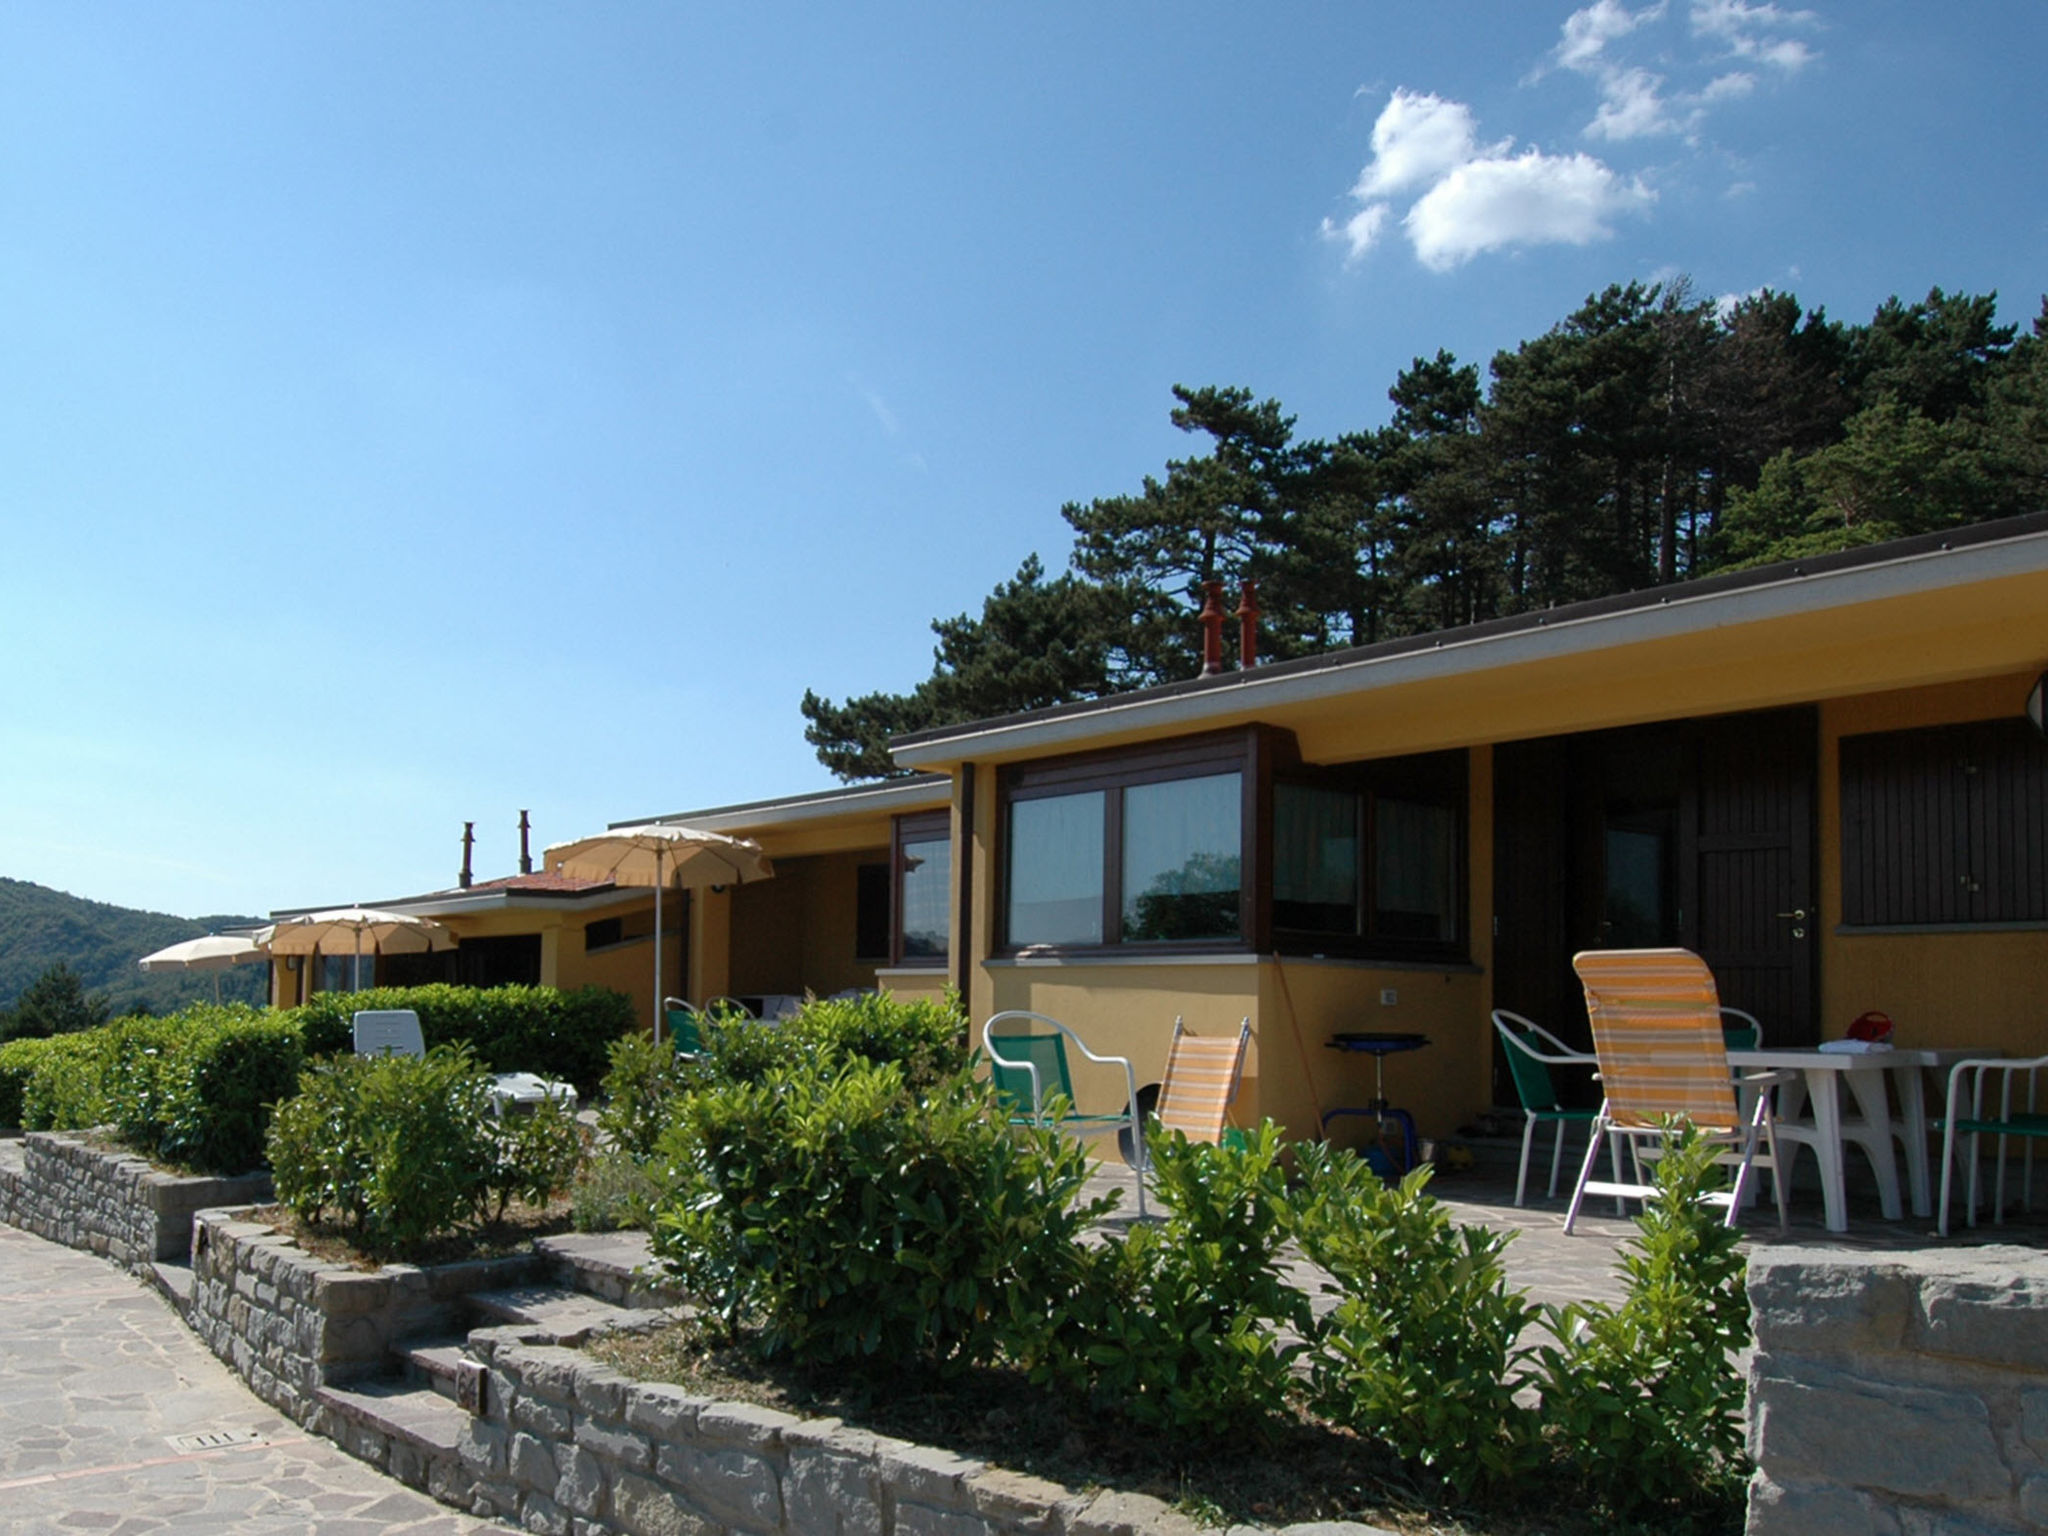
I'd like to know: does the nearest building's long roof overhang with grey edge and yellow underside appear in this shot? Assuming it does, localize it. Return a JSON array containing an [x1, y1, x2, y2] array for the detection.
[[891, 514, 2048, 772]]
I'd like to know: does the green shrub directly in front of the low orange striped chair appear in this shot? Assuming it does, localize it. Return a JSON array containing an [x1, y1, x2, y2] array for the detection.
[[1036, 1120, 1311, 1442]]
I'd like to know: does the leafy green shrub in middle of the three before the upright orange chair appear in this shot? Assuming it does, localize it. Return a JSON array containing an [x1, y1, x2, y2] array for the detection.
[[1294, 1145, 1540, 1495]]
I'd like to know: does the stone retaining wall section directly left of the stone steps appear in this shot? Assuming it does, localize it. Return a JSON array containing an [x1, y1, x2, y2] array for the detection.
[[184, 1210, 539, 1423]]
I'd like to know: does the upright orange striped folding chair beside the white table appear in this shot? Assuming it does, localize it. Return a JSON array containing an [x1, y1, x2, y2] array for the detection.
[[1565, 950, 1792, 1233]]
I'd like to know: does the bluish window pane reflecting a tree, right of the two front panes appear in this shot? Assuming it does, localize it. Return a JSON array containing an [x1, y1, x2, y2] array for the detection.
[[1124, 774, 1243, 944]]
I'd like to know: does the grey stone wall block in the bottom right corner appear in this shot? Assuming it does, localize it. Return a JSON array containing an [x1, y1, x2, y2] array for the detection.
[[1749, 1247, 2048, 1536]]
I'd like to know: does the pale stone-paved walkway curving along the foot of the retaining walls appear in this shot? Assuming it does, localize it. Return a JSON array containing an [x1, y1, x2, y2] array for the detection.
[[0, 1225, 502, 1536]]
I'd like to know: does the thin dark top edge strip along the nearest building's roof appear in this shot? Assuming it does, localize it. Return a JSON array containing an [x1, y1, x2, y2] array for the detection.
[[889, 512, 2048, 752]]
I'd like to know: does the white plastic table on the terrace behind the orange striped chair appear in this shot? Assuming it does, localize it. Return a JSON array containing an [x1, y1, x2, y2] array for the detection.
[[1729, 1049, 1997, 1233]]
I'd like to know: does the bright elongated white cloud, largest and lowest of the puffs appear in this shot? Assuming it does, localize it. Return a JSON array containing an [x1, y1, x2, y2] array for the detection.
[[1403, 150, 1657, 272]]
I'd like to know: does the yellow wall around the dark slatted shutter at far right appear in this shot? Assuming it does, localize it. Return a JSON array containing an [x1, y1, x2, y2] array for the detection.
[[1819, 670, 2048, 1057]]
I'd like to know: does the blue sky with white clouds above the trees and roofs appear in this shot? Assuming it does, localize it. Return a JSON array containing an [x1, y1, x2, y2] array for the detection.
[[0, 0, 2048, 913]]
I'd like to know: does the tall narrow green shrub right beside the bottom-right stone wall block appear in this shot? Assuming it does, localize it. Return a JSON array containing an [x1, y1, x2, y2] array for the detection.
[[1538, 1133, 1749, 1516]]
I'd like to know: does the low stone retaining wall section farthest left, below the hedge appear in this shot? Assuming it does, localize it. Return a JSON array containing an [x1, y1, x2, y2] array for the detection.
[[0, 1130, 270, 1270]]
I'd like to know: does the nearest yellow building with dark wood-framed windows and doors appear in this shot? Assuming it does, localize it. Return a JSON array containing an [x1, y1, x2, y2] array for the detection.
[[864, 516, 2048, 1135]]
